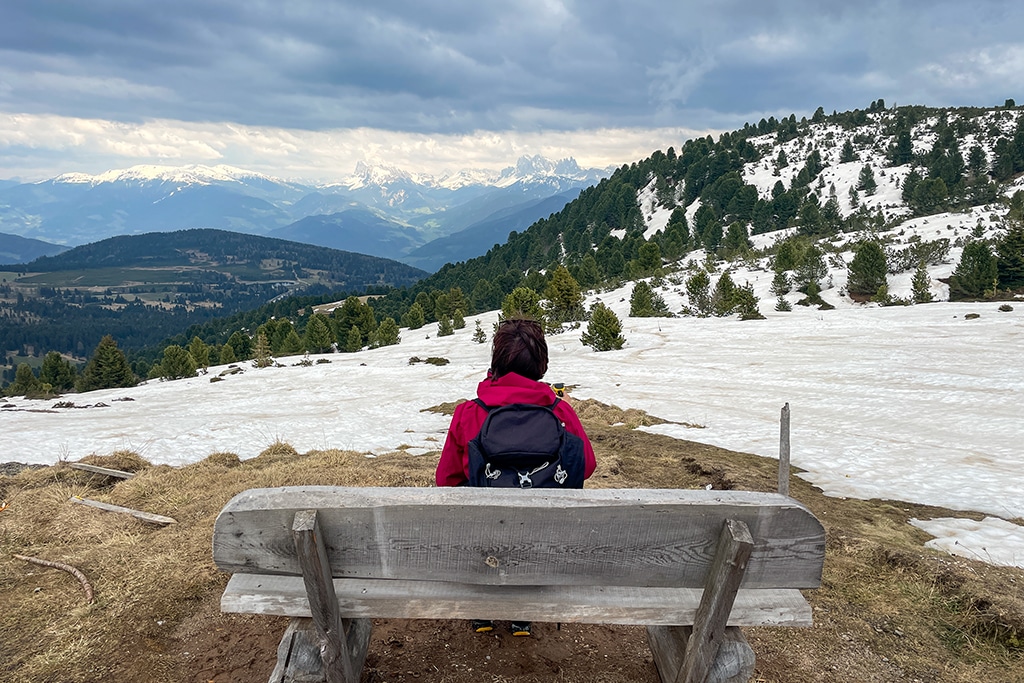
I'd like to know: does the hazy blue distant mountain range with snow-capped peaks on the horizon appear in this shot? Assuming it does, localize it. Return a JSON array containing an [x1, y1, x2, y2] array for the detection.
[[0, 157, 608, 266]]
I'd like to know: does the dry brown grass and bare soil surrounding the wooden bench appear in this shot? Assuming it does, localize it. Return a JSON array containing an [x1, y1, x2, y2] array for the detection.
[[0, 401, 1024, 683]]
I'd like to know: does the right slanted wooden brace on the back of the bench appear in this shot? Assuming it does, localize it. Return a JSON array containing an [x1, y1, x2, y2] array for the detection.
[[676, 519, 754, 683]]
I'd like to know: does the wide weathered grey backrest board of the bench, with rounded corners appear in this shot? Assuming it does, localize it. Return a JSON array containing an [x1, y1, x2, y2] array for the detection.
[[213, 486, 824, 589]]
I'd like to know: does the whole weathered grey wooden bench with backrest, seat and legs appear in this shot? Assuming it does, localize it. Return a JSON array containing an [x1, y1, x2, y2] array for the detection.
[[213, 486, 824, 683]]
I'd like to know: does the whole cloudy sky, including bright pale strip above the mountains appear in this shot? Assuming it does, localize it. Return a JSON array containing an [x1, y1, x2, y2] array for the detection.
[[0, 0, 1024, 180]]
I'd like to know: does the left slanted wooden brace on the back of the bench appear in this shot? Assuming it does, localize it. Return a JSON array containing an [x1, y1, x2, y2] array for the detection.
[[292, 510, 361, 683]]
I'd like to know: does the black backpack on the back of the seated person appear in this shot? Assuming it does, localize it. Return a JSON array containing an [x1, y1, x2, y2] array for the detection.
[[469, 398, 585, 488]]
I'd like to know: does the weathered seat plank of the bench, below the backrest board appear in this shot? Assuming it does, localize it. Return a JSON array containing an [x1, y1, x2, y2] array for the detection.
[[220, 573, 812, 627]]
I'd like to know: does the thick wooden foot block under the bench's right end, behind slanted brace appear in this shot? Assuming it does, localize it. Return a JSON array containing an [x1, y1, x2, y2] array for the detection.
[[647, 626, 755, 683]]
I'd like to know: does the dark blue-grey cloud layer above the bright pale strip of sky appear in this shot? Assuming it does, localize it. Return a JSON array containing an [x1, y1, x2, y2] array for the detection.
[[0, 0, 1024, 133]]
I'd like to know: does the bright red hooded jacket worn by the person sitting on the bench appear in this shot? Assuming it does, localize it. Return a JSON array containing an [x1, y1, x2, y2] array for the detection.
[[434, 373, 597, 486]]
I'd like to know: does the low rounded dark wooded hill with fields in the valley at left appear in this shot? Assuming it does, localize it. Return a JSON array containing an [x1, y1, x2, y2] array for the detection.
[[0, 229, 426, 381]]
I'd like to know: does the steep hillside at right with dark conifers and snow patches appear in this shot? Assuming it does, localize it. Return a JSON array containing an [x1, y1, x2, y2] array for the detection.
[[374, 100, 1024, 319]]
